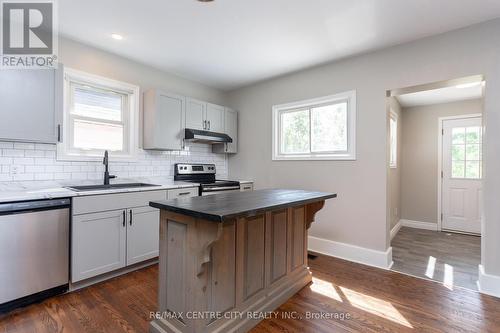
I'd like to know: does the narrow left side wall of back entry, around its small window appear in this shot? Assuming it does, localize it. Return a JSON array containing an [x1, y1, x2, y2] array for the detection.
[[387, 97, 403, 229]]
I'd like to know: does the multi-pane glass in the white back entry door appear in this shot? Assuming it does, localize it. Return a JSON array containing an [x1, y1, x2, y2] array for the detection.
[[451, 126, 482, 179]]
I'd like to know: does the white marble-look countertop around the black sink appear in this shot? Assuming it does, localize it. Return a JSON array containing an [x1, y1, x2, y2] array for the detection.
[[0, 178, 199, 203]]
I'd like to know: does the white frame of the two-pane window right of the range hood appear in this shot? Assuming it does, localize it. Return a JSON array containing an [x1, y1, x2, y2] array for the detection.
[[272, 90, 356, 161]]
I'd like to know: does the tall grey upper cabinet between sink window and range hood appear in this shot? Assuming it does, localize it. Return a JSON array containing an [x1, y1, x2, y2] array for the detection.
[[143, 90, 186, 150]]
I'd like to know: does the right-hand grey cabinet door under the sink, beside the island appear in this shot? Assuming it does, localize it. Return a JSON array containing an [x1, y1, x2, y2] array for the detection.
[[127, 207, 160, 266]]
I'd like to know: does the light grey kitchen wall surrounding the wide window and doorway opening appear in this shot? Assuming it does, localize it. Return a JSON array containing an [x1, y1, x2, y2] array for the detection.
[[229, 20, 500, 275]]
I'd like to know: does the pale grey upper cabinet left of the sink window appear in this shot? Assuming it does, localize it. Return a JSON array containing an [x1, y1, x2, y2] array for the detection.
[[0, 65, 63, 143]]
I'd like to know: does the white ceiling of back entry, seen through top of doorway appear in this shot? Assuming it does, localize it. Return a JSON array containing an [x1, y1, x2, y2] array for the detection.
[[396, 85, 483, 108]]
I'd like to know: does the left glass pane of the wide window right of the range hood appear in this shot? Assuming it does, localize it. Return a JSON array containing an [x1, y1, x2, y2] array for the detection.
[[281, 110, 309, 154]]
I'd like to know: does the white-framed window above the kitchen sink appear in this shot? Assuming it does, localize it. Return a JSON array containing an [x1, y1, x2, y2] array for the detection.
[[57, 69, 139, 160]]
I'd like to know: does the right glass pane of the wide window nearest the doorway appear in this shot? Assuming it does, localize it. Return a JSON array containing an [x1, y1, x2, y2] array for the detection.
[[311, 102, 347, 152]]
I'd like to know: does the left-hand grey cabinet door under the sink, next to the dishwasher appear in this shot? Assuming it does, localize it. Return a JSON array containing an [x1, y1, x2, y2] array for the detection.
[[71, 210, 127, 282]]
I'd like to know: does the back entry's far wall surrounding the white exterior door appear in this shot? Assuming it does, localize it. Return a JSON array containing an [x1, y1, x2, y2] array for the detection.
[[401, 99, 483, 223]]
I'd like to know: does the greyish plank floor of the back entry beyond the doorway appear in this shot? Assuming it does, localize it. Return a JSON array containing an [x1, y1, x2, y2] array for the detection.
[[391, 227, 481, 290]]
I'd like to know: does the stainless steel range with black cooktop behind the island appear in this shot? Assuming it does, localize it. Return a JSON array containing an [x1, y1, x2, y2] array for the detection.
[[174, 163, 240, 195]]
